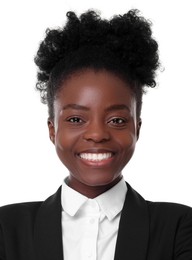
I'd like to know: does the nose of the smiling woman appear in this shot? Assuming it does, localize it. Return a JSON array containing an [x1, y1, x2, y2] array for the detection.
[[83, 122, 110, 143]]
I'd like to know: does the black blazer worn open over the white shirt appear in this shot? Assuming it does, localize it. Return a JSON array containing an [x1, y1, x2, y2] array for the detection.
[[0, 184, 192, 260]]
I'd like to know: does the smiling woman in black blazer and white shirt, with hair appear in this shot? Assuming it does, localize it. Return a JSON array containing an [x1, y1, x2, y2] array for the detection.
[[0, 10, 192, 260]]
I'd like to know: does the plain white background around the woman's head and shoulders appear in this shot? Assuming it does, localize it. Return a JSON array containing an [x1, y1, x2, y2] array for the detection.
[[0, 0, 192, 206]]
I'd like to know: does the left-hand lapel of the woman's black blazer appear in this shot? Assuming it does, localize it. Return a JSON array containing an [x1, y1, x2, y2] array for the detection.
[[34, 187, 63, 260]]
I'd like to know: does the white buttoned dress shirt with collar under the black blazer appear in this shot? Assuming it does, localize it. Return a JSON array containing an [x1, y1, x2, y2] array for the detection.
[[61, 179, 127, 260]]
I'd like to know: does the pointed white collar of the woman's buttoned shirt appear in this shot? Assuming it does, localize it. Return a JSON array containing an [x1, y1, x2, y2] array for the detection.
[[61, 178, 127, 221]]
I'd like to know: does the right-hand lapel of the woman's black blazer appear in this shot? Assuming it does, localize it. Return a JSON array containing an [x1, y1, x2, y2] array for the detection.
[[115, 184, 149, 260]]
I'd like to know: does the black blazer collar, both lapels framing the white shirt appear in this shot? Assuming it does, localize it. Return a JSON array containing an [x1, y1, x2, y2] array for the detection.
[[34, 184, 149, 260]]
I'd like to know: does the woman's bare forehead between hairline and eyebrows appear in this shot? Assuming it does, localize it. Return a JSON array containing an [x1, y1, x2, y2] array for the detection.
[[55, 69, 135, 110]]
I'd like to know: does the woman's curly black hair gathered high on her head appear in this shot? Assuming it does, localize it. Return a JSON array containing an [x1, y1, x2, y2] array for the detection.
[[34, 9, 160, 118]]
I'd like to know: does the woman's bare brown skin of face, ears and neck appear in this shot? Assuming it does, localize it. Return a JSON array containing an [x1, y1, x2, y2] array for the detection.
[[48, 69, 141, 198]]
